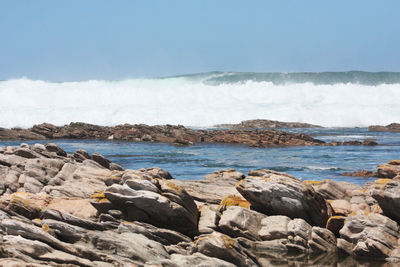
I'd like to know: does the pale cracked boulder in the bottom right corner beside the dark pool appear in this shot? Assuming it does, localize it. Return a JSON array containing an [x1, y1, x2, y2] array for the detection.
[[338, 212, 399, 259]]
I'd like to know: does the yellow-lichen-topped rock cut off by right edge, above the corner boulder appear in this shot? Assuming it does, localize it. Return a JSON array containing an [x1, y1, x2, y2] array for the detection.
[[371, 179, 400, 223]]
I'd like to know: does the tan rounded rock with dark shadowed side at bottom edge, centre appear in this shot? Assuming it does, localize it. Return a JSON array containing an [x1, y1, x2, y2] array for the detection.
[[191, 232, 258, 266]]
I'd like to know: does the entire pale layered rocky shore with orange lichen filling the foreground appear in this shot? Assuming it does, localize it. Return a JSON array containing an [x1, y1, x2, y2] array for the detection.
[[0, 143, 400, 267]]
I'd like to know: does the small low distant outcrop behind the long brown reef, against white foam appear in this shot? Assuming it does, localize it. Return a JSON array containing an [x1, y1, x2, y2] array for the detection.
[[214, 120, 322, 129]]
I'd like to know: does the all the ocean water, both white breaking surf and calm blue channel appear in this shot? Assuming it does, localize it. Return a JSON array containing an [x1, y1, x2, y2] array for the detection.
[[0, 71, 400, 184]]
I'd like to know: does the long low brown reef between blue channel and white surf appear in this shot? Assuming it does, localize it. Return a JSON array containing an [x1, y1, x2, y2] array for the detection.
[[0, 122, 377, 147]]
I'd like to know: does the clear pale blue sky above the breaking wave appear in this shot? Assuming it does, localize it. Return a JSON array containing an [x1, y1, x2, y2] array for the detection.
[[0, 0, 400, 81]]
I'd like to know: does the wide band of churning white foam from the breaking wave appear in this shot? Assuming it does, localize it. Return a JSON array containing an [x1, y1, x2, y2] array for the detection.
[[0, 77, 400, 127]]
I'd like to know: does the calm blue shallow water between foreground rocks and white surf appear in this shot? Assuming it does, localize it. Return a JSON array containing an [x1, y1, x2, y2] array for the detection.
[[0, 128, 400, 184]]
